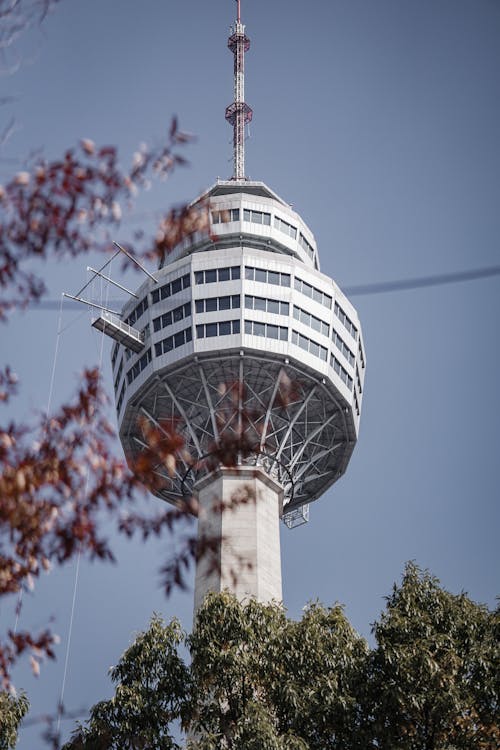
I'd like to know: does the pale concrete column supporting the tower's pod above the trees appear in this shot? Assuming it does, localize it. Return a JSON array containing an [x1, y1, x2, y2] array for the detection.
[[194, 466, 283, 613]]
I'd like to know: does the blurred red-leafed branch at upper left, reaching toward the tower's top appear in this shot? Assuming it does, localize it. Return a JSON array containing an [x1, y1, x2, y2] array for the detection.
[[0, 118, 195, 317]]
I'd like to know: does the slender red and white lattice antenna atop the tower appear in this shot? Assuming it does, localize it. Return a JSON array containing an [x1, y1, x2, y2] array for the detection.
[[226, 0, 253, 180]]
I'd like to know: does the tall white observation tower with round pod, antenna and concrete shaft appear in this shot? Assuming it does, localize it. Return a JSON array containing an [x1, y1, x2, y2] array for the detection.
[[93, 2, 365, 610]]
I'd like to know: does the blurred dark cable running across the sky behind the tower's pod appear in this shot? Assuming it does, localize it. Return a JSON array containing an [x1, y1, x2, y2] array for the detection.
[[31, 266, 500, 310]]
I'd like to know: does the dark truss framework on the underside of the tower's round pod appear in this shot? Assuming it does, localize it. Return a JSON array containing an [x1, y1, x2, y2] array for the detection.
[[121, 352, 355, 512]]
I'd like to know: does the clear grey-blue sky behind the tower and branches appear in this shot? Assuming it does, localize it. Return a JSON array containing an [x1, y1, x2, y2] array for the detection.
[[0, 0, 500, 750]]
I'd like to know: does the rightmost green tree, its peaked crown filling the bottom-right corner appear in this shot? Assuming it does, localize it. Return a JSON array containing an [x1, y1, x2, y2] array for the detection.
[[363, 563, 500, 750]]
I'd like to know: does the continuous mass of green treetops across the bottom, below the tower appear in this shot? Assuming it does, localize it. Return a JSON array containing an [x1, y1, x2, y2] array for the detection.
[[66, 564, 500, 750]]
